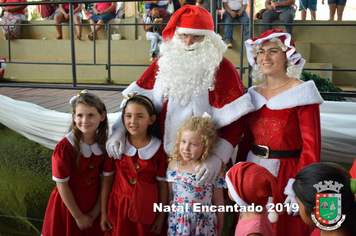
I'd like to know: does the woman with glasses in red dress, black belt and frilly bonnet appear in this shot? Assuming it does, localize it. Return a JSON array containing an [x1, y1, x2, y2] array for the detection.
[[237, 30, 323, 236]]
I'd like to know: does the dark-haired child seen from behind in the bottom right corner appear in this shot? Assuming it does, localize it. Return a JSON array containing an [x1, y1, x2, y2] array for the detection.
[[293, 162, 356, 236]]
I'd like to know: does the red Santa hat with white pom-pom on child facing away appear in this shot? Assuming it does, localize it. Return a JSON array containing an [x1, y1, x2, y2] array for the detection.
[[226, 162, 283, 223]]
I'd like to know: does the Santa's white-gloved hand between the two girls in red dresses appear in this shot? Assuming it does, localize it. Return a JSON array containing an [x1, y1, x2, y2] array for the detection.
[[106, 129, 126, 160]]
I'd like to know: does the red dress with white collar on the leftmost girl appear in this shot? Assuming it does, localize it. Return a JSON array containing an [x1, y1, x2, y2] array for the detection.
[[42, 131, 115, 236]]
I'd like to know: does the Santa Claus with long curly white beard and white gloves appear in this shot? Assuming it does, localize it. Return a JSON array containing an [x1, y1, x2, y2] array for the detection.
[[107, 5, 254, 183]]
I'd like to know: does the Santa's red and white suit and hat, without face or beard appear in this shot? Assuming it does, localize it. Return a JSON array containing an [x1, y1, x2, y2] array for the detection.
[[107, 5, 254, 177]]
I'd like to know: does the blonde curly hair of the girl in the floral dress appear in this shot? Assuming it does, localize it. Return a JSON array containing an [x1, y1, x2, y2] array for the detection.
[[168, 117, 226, 176]]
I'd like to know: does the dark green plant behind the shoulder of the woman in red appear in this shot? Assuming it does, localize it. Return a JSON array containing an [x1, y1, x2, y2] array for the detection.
[[300, 70, 346, 101]]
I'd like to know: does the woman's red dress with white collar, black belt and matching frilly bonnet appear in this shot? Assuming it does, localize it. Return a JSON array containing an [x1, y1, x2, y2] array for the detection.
[[237, 30, 323, 236]]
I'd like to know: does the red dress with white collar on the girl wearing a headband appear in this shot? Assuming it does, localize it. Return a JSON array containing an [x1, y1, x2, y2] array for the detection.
[[105, 136, 167, 236]]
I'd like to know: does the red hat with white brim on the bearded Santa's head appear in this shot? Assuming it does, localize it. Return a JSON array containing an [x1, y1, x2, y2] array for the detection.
[[162, 5, 215, 42]]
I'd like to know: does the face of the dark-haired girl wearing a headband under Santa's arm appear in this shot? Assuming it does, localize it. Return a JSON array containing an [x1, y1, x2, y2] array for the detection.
[[124, 103, 156, 137]]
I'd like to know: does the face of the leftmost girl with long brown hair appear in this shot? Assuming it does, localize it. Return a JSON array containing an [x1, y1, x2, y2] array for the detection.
[[73, 103, 105, 137]]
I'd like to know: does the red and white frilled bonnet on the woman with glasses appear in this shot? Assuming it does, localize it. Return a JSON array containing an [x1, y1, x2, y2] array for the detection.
[[245, 29, 305, 67]]
